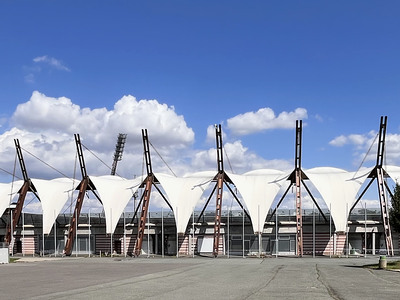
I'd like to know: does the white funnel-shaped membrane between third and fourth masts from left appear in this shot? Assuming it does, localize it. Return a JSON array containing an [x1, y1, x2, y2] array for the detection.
[[155, 171, 216, 233]]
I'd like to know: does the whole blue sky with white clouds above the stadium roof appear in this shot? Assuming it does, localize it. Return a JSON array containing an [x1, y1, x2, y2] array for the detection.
[[0, 0, 400, 182]]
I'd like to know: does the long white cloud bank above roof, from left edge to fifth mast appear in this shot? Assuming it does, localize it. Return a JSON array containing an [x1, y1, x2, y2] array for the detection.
[[0, 91, 292, 186]]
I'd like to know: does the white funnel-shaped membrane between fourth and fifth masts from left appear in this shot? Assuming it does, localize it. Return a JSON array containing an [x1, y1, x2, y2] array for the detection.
[[227, 169, 284, 233]]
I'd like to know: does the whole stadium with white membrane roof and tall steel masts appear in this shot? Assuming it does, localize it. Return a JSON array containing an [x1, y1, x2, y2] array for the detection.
[[0, 117, 400, 257]]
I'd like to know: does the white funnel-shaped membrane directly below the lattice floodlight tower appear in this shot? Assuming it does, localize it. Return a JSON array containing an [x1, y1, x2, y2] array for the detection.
[[90, 175, 143, 234]]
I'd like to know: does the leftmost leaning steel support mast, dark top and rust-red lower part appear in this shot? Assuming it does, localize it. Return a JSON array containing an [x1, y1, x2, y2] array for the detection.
[[5, 139, 40, 243]]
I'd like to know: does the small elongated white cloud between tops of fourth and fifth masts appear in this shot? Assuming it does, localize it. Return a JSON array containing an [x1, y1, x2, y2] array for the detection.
[[227, 107, 307, 135]]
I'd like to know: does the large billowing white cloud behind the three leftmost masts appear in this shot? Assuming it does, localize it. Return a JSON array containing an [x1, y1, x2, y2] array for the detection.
[[0, 91, 194, 178]]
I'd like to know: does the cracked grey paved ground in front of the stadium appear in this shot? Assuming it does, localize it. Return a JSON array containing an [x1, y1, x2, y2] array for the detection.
[[0, 256, 400, 300]]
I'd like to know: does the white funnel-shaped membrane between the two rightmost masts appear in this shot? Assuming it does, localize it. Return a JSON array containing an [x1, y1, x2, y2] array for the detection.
[[304, 167, 371, 232]]
